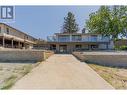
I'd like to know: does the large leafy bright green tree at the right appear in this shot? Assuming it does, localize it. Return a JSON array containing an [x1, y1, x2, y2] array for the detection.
[[86, 6, 127, 39]]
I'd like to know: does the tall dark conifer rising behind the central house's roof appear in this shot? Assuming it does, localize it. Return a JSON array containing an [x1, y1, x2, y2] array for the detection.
[[62, 12, 79, 33]]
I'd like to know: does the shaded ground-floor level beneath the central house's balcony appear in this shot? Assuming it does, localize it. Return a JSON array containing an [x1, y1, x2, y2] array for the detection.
[[49, 42, 109, 53]]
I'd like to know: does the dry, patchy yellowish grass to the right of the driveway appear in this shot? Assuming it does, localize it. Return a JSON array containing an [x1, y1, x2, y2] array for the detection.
[[88, 64, 127, 89]]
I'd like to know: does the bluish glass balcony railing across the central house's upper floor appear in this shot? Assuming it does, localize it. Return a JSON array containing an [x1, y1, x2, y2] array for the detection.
[[47, 36, 110, 42]]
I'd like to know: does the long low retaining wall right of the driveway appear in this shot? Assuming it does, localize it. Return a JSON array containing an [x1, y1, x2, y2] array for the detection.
[[73, 52, 127, 67]]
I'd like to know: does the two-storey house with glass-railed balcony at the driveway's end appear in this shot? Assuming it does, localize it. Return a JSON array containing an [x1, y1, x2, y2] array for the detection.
[[47, 33, 114, 53]]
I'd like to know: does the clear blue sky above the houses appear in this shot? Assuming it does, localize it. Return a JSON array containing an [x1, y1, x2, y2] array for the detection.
[[2, 6, 99, 39]]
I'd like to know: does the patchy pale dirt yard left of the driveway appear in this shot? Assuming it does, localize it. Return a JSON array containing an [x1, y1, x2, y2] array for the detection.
[[0, 63, 39, 89]]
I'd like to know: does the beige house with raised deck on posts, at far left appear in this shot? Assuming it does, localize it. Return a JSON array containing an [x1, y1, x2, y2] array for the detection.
[[0, 23, 36, 49]]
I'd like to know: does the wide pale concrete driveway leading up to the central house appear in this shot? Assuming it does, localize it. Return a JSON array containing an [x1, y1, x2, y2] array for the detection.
[[12, 54, 113, 89]]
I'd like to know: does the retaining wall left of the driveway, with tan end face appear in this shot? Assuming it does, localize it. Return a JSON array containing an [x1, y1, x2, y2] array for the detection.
[[0, 50, 53, 62]]
